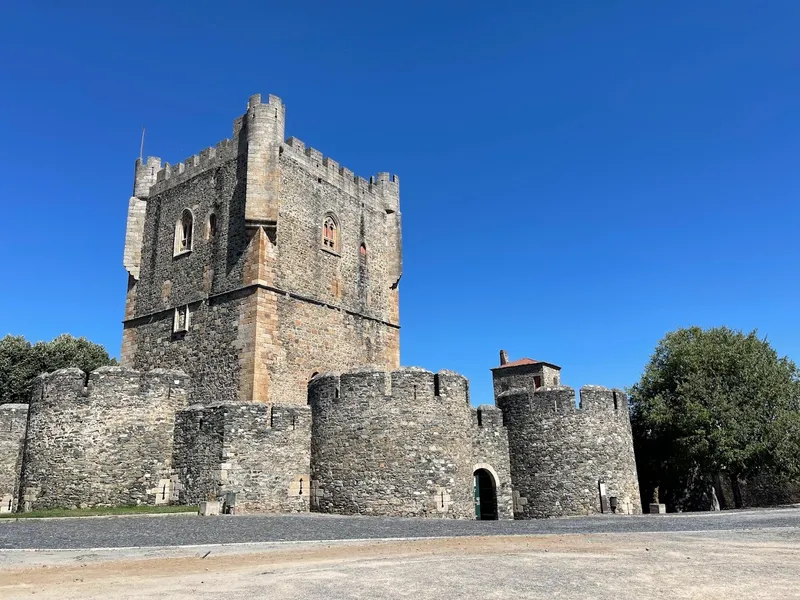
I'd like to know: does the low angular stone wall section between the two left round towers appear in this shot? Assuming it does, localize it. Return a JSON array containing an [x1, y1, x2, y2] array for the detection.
[[174, 402, 311, 512]]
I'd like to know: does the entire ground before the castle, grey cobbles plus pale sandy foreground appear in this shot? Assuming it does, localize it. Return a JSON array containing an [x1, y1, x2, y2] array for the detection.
[[0, 508, 800, 600]]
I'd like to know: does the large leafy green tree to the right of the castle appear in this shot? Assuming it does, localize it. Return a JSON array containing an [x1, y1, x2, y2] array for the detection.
[[630, 327, 800, 509]]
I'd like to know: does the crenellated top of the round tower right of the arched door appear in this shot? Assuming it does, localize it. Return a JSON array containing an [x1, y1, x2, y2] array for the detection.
[[497, 385, 628, 420]]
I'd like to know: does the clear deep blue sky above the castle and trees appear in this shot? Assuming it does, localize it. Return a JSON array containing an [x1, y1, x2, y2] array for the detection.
[[0, 0, 800, 403]]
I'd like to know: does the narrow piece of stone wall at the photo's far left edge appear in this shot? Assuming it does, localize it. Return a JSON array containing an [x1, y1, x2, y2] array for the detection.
[[0, 404, 28, 513]]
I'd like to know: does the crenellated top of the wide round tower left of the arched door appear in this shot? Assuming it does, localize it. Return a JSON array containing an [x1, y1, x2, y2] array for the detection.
[[308, 367, 469, 410]]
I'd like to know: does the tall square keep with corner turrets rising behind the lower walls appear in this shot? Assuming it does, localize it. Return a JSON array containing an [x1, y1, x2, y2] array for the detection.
[[121, 95, 402, 404]]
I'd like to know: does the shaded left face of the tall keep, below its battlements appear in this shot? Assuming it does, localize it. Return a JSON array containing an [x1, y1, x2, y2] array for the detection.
[[121, 150, 247, 402]]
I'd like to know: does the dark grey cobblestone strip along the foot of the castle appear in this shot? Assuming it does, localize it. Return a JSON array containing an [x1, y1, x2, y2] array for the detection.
[[0, 507, 800, 549]]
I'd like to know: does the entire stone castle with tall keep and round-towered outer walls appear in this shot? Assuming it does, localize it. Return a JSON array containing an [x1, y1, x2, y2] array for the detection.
[[0, 95, 641, 519]]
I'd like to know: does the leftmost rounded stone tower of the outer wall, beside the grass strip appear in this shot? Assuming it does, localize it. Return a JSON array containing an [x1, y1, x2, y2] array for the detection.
[[21, 367, 187, 510]]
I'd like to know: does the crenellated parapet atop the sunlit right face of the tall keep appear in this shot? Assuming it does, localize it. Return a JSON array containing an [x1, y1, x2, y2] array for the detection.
[[281, 137, 400, 211]]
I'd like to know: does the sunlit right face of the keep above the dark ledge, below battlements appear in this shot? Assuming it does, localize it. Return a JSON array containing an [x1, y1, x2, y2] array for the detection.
[[276, 152, 402, 328]]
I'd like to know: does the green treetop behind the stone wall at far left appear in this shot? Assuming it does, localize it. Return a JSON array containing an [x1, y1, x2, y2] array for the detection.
[[0, 334, 117, 404]]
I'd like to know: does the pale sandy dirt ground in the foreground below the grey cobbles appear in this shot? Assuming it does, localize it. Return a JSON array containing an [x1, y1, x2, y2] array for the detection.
[[0, 531, 800, 600]]
